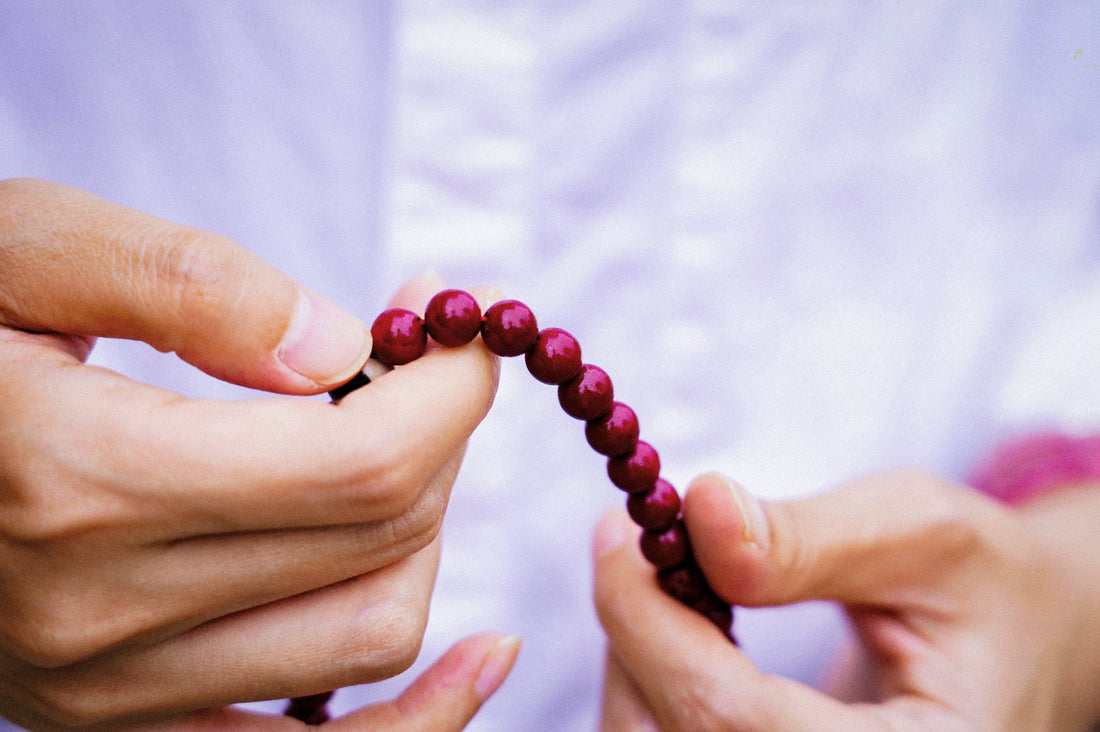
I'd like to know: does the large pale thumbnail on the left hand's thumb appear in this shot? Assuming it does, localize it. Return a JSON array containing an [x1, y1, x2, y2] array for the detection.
[[276, 288, 371, 386]]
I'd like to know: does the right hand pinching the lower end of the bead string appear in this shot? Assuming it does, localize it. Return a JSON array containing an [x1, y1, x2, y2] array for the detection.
[[595, 471, 1100, 732]]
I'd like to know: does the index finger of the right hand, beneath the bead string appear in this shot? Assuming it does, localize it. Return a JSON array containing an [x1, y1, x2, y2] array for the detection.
[[595, 512, 881, 732]]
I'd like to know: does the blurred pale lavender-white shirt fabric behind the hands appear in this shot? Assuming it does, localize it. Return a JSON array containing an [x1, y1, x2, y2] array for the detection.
[[0, 0, 1100, 730]]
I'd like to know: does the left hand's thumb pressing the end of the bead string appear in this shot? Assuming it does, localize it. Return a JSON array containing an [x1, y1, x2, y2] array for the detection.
[[0, 179, 371, 393]]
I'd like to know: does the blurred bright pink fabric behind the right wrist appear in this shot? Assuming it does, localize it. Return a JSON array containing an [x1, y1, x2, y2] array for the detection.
[[970, 431, 1100, 504]]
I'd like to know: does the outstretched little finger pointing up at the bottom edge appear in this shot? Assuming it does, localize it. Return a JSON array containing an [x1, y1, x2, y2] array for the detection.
[[329, 633, 519, 732]]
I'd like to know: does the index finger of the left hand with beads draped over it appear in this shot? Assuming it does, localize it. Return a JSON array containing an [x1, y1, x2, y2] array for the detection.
[[0, 317, 498, 536]]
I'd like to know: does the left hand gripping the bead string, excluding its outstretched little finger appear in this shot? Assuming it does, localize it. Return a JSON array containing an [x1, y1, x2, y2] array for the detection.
[[0, 181, 497, 729]]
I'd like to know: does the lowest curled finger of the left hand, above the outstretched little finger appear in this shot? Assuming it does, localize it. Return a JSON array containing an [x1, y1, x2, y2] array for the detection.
[[0, 539, 439, 729]]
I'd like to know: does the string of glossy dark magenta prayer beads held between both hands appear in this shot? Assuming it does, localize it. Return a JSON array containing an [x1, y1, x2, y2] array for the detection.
[[285, 289, 736, 724]]
